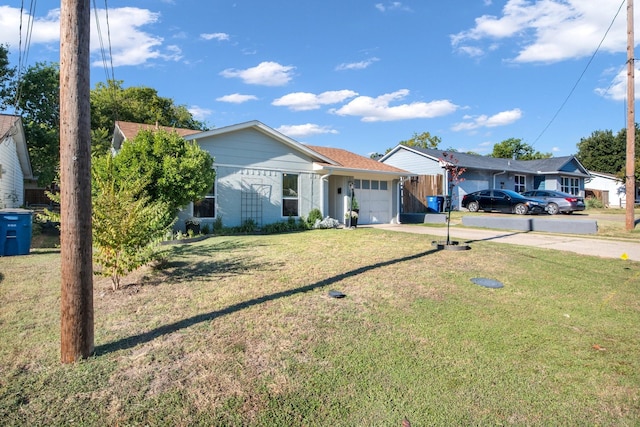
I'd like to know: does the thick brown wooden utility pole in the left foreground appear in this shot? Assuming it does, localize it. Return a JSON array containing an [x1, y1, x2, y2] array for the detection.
[[60, 0, 94, 363]]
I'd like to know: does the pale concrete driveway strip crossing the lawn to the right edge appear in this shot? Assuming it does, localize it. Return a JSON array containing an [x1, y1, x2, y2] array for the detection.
[[364, 224, 640, 261]]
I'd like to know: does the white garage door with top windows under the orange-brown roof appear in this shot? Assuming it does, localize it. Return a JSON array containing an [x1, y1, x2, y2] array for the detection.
[[354, 179, 392, 224]]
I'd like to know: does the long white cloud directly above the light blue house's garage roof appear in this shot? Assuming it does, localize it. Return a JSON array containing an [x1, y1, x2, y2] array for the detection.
[[331, 89, 458, 122]]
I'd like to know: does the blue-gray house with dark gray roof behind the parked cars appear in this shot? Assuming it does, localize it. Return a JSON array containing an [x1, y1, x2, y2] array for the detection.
[[379, 145, 590, 212]]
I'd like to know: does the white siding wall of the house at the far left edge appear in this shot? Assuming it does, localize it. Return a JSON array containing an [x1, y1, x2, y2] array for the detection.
[[0, 136, 24, 209]]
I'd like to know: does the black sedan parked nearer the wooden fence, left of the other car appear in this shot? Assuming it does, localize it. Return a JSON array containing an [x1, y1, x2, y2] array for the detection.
[[462, 190, 547, 215]]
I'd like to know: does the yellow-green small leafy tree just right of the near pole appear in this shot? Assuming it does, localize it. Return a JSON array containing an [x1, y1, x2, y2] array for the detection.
[[92, 153, 173, 290]]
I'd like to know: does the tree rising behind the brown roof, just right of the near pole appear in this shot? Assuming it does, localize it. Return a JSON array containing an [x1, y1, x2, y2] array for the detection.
[[91, 80, 207, 155]]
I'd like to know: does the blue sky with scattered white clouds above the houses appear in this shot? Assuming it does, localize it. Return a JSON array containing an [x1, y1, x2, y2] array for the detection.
[[0, 0, 640, 156]]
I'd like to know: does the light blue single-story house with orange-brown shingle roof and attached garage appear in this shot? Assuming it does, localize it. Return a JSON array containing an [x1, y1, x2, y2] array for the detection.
[[113, 121, 410, 228]]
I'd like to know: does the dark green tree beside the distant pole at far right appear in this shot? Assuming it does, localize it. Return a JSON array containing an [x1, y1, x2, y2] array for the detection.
[[576, 124, 640, 176]]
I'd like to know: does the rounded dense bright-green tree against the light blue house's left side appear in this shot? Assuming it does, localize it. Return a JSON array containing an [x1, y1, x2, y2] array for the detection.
[[104, 130, 215, 218]]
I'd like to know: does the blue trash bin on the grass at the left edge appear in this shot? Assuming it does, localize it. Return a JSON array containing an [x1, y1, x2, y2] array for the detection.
[[0, 209, 33, 256]]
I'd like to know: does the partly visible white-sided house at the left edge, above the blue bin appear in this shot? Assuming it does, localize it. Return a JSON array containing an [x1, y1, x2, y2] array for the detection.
[[0, 114, 33, 209]]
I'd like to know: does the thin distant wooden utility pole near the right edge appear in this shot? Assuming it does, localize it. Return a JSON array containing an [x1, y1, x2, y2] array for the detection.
[[625, 0, 636, 231]]
